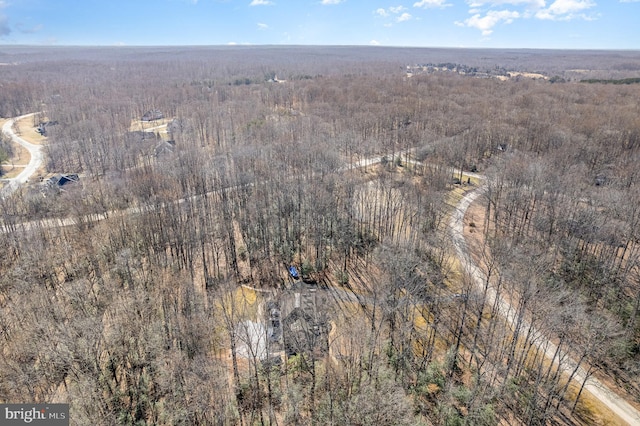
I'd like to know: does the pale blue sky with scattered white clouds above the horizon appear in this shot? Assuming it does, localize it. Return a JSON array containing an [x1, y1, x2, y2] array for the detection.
[[0, 0, 640, 50]]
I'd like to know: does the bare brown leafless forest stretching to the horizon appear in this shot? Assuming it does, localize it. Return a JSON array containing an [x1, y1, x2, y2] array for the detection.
[[0, 47, 640, 425]]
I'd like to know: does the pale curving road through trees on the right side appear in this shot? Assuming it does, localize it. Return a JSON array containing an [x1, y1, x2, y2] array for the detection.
[[449, 186, 640, 426]]
